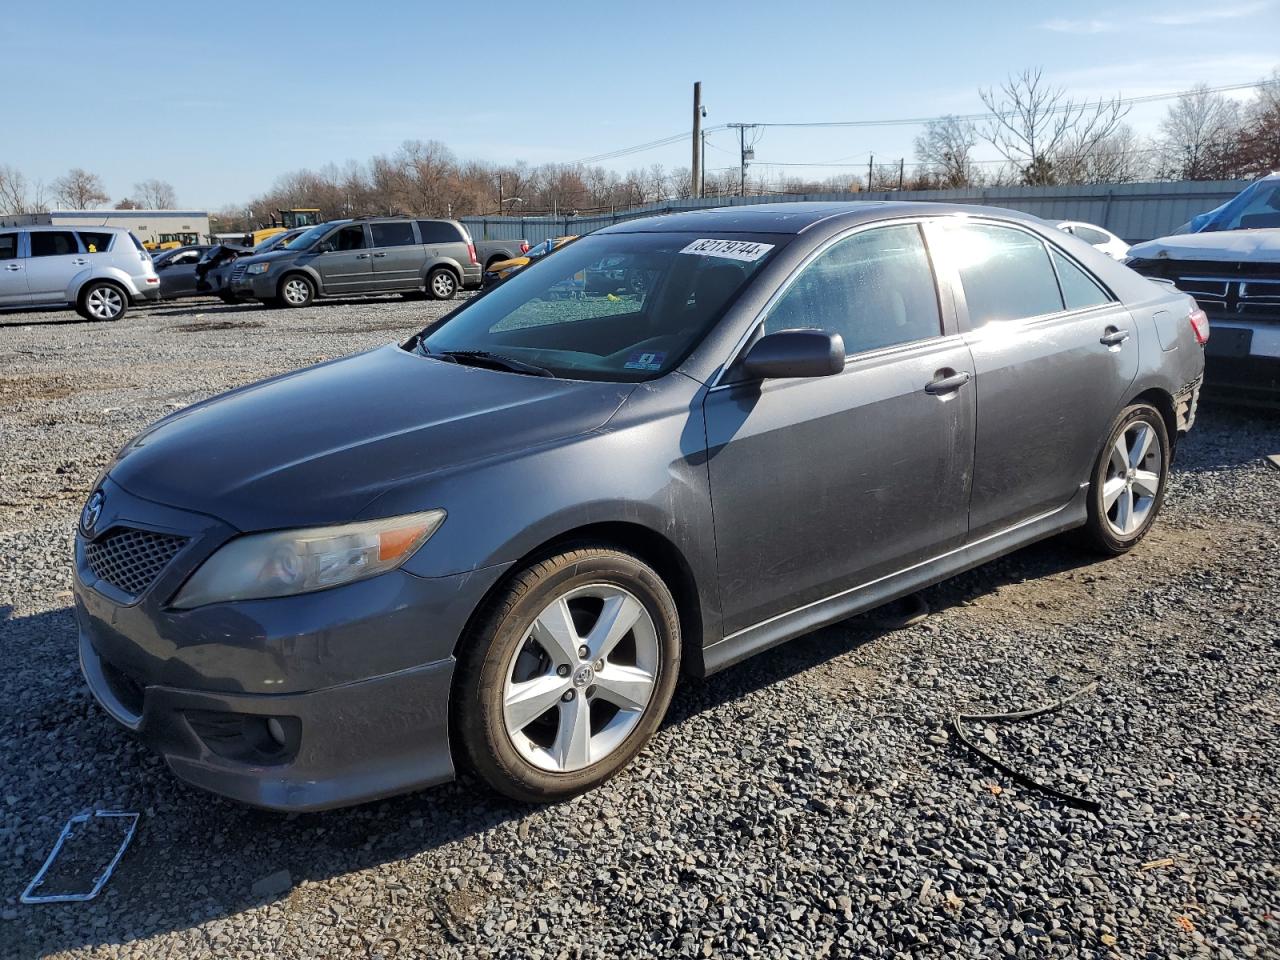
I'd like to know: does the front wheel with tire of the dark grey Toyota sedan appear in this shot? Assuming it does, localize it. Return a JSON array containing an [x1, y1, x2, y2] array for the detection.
[[453, 545, 680, 803]]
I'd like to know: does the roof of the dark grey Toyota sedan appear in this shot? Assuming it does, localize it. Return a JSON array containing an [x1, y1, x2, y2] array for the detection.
[[599, 200, 1043, 233]]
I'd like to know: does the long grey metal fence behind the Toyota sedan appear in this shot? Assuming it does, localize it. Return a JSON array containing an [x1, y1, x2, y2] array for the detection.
[[462, 180, 1249, 243]]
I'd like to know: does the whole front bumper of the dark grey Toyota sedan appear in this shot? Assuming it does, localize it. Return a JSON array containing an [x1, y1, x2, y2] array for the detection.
[[73, 477, 506, 810]]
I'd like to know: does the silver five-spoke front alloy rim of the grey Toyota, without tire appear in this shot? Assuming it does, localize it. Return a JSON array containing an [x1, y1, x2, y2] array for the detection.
[[502, 584, 660, 773]]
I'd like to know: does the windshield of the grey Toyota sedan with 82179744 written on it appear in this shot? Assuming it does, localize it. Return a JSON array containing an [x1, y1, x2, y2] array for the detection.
[[419, 233, 791, 381]]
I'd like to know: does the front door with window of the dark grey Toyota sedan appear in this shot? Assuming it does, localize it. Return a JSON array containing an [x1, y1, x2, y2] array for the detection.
[[705, 223, 975, 634]]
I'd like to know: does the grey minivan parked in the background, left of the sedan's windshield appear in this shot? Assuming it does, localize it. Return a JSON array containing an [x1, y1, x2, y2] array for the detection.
[[229, 216, 480, 307]]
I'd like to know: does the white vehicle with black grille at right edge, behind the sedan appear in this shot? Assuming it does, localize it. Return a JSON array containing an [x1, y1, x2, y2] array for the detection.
[[1126, 173, 1280, 406]]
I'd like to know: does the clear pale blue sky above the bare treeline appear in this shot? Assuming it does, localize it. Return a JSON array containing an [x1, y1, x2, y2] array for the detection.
[[0, 0, 1280, 209]]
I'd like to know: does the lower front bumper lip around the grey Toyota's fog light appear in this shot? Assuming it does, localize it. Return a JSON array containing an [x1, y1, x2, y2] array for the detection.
[[79, 631, 454, 812]]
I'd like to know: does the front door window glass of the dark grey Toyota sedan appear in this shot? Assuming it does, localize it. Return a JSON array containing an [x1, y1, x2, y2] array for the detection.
[[764, 224, 942, 355]]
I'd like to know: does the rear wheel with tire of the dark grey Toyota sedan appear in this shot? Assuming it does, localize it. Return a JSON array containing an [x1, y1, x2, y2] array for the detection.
[[1080, 403, 1171, 557]]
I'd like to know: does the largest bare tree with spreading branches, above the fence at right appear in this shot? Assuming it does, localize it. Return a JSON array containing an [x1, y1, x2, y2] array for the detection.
[[978, 68, 1129, 186]]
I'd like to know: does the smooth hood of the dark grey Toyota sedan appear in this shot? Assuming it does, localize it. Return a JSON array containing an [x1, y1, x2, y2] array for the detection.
[[110, 344, 635, 530]]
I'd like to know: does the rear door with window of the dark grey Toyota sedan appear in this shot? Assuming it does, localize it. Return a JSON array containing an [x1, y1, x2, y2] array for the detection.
[[931, 218, 1138, 539]]
